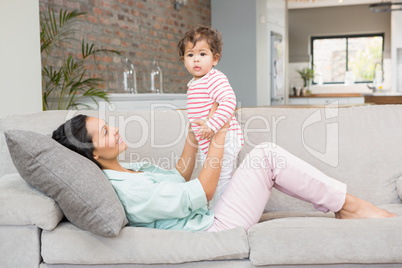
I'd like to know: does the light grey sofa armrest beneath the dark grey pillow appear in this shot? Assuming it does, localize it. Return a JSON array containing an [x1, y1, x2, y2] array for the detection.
[[0, 173, 63, 230]]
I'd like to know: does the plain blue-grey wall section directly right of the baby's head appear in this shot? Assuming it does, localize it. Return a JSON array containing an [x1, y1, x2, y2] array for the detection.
[[211, 0, 257, 107]]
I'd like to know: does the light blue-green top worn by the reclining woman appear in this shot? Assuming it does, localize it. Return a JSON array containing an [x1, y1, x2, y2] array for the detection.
[[103, 162, 214, 231]]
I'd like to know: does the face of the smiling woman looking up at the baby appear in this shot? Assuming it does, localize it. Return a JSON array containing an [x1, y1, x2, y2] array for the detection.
[[86, 117, 127, 162]]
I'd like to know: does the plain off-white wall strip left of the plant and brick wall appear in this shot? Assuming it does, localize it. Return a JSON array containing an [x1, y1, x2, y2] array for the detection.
[[0, 0, 42, 118]]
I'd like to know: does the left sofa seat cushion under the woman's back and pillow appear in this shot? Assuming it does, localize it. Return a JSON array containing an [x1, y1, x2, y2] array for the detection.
[[42, 222, 249, 264]]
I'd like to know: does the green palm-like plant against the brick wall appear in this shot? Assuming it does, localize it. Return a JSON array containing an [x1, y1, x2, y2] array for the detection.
[[40, 7, 120, 110]]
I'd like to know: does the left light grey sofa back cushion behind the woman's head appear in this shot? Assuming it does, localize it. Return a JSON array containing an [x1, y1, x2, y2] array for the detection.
[[0, 110, 187, 177]]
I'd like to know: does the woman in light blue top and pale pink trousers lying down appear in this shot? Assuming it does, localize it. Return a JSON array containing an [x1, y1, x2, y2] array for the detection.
[[53, 115, 395, 231]]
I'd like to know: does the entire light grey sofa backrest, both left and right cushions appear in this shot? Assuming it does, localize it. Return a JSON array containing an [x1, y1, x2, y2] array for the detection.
[[0, 105, 402, 211]]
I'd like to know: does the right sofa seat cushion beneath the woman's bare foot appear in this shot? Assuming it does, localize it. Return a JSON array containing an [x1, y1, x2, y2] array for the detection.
[[249, 204, 402, 265]]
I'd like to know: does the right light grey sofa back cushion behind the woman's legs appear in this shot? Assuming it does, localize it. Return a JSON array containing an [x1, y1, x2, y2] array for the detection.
[[237, 105, 402, 211]]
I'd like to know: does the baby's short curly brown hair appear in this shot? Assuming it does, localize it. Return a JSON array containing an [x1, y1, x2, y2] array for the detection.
[[177, 25, 223, 57]]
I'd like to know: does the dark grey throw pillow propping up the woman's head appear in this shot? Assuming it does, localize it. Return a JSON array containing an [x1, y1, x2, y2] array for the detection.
[[4, 130, 127, 236]]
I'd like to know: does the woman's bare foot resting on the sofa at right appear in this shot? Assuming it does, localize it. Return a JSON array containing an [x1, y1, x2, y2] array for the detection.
[[335, 194, 396, 219]]
